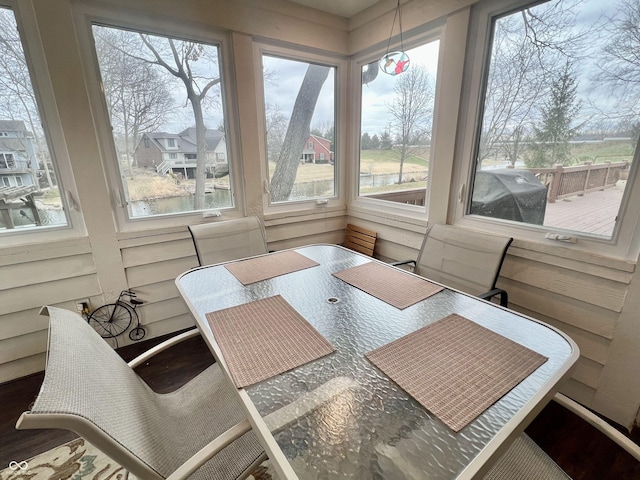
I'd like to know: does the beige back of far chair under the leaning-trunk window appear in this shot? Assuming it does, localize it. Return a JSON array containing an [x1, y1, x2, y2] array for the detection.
[[189, 217, 268, 265]]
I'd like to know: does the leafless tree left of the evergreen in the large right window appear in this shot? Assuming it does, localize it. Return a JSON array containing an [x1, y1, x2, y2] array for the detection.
[[478, 0, 590, 165]]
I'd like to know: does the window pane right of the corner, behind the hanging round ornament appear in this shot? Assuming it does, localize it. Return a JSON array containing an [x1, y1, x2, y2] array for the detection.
[[358, 40, 440, 205]]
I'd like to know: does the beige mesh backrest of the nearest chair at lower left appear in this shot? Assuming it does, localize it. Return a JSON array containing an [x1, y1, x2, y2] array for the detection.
[[17, 307, 168, 479]]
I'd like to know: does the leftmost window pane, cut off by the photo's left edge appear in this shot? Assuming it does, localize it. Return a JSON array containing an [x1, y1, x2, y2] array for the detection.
[[0, 8, 70, 234]]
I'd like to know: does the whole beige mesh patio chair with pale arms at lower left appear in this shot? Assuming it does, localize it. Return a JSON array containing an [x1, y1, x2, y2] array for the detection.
[[16, 307, 266, 480]]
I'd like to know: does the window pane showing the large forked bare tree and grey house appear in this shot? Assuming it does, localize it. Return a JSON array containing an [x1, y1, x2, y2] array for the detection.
[[92, 23, 234, 219]]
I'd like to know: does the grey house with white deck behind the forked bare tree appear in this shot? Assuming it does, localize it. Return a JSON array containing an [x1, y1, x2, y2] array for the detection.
[[133, 128, 229, 178]]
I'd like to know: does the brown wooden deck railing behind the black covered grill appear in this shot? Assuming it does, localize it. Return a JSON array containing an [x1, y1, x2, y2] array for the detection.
[[529, 162, 629, 203]]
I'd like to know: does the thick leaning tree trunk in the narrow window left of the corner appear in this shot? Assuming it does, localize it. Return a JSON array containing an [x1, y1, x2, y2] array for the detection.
[[271, 64, 331, 202]]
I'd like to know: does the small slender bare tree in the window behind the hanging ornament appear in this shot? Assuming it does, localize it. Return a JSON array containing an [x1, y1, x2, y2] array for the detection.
[[387, 66, 434, 183]]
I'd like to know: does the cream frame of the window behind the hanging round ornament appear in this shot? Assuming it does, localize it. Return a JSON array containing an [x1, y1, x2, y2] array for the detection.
[[349, 23, 446, 224]]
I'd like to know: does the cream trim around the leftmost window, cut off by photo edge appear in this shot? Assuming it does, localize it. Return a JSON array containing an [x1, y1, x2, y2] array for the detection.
[[0, 0, 87, 247]]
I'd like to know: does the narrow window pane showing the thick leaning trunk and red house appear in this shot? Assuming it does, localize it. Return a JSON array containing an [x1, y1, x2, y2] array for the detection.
[[262, 54, 339, 203]]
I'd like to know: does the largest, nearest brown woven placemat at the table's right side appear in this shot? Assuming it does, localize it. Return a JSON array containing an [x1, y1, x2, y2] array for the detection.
[[366, 314, 547, 432]]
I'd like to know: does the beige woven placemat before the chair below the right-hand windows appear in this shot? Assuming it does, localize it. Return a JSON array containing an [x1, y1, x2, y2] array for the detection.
[[333, 262, 442, 310]]
